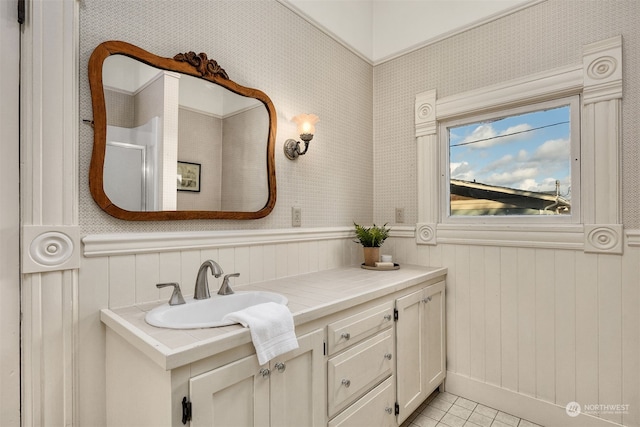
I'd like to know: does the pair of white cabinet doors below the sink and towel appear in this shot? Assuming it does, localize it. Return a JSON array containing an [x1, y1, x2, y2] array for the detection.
[[189, 330, 325, 427]]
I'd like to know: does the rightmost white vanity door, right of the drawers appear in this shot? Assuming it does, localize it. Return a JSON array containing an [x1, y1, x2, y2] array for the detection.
[[396, 282, 446, 424]]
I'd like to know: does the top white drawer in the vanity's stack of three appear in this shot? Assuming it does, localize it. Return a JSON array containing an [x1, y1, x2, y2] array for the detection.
[[327, 301, 393, 354]]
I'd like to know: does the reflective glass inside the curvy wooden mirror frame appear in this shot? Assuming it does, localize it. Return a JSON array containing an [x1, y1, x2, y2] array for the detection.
[[102, 55, 269, 211]]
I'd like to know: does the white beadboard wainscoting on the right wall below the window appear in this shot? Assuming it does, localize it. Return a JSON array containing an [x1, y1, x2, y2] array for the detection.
[[384, 231, 640, 426]]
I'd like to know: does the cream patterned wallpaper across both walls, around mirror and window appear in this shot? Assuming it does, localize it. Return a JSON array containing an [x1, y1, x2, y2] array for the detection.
[[80, 0, 640, 233]]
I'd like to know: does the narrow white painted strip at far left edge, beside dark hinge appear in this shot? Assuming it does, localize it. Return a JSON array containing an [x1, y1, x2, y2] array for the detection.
[[0, 2, 20, 427]]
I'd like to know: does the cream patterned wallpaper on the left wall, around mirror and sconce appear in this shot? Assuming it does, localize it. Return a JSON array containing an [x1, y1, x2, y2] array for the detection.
[[79, 0, 373, 234]]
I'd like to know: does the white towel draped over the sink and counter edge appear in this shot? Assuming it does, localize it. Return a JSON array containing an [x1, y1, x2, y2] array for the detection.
[[222, 302, 298, 365]]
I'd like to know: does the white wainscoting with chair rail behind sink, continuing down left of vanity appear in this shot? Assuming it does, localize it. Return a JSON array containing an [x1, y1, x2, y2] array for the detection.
[[77, 227, 360, 426]]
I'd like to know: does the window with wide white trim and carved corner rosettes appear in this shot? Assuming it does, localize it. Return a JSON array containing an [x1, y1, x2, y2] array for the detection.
[[414, 36, 624, 254]]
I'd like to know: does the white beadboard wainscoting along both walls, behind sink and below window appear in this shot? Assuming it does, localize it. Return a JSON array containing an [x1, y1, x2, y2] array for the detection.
[[78, 227, 640, 427]]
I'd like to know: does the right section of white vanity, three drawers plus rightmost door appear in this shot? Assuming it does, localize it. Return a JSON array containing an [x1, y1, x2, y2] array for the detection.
[[327, 281, 446, 427]]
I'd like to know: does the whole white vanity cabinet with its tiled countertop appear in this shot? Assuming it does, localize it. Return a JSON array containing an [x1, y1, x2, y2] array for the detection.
[[101, 266, 446, 427]]
